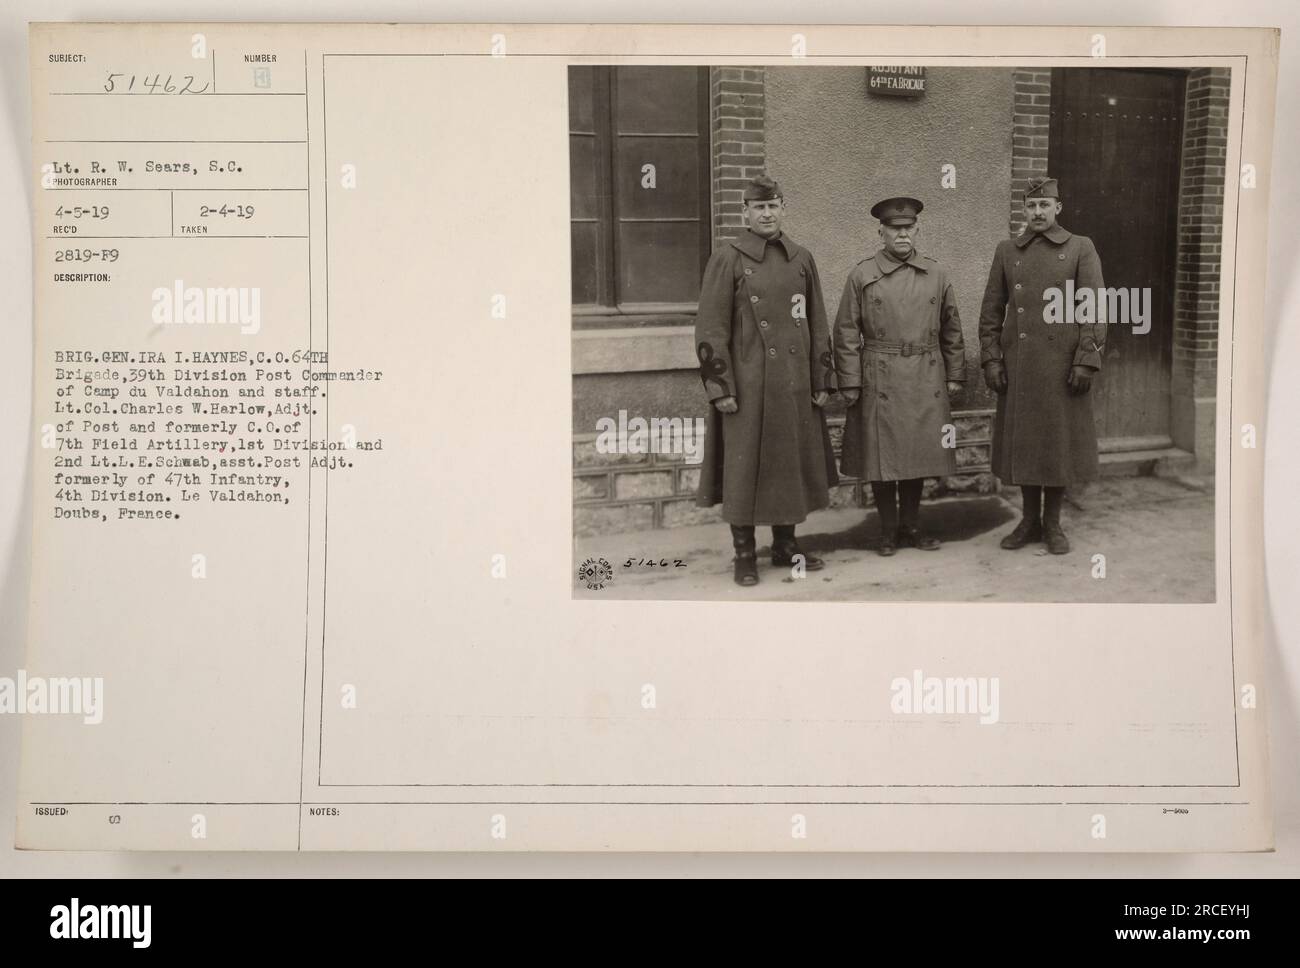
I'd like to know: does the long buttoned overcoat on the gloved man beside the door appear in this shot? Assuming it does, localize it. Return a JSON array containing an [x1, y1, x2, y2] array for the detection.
[[979, 225, 1106, 487]]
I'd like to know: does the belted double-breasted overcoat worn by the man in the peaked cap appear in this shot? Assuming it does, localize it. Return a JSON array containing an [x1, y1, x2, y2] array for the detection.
[[833, 249, 966, 481]]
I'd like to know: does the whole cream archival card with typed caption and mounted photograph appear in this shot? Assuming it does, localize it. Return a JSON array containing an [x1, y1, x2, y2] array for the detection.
[[17, 23, 1278, 852]]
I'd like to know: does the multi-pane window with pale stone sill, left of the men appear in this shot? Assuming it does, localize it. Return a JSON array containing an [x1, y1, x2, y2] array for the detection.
[[568, 66, 710, 326]]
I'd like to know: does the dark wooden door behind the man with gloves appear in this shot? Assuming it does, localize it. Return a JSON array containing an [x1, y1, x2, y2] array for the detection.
[[1048, 68, 1187, 451]]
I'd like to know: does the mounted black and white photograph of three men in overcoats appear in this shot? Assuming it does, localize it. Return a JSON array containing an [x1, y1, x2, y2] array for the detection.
[[568, 65, 1227, 603]]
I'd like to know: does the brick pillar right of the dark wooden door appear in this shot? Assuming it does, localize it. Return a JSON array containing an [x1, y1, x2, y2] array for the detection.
[[1173, 68, 1231, 473]]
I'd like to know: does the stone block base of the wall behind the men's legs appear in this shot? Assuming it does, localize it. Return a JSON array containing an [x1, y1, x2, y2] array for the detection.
[[573, 411, 997, 535]]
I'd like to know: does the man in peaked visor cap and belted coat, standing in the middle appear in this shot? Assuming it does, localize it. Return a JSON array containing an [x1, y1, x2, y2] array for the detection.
[[835, 196, 966, 556]]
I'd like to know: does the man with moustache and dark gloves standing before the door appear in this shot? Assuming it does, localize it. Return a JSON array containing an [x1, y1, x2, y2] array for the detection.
[[979, 178, 1106, 555]]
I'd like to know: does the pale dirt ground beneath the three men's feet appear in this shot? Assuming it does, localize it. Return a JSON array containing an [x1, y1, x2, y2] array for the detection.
[[573, 477, 1214, 603]]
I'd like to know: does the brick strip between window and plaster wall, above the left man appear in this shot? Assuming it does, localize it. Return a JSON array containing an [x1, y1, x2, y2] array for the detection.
[[709, 68, 767, 248]]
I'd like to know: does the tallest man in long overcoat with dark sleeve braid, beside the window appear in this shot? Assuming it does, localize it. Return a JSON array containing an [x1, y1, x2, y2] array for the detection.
[[696, 175, 839, 585]]
